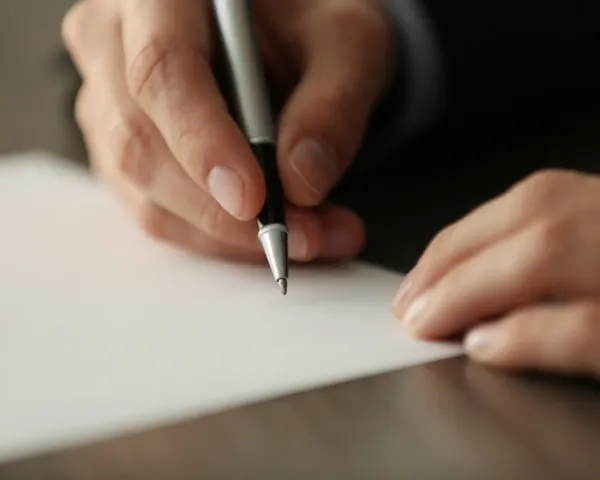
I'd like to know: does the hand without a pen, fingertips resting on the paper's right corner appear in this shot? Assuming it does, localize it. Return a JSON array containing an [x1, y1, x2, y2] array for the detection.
[[394, 170, 600, 376]]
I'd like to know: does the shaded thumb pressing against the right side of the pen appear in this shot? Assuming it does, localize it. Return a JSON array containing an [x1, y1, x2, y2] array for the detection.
[[278, 2, 390, 206]]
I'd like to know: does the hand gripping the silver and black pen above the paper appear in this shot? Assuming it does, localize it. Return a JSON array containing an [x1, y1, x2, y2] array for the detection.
[[58, 0, 393, 261]]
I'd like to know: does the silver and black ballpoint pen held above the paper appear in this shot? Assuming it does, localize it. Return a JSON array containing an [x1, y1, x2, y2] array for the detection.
[[213, 0, 288, 295]]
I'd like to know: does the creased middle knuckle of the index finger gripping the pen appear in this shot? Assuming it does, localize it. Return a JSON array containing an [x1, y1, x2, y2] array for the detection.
[[126, 36, 177, 99]]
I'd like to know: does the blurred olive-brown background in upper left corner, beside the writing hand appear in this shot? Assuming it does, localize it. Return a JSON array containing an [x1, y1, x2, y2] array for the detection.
[[0, 0, 84, 161]]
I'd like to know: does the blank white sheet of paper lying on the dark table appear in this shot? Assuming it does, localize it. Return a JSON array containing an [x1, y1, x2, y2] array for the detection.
[[0, 153, 460, 460]]
